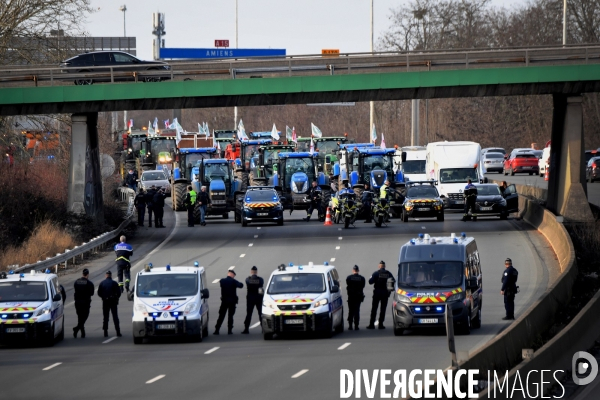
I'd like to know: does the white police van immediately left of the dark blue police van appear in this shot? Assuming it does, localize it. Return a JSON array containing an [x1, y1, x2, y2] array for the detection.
[[262, 262, 344, 340]]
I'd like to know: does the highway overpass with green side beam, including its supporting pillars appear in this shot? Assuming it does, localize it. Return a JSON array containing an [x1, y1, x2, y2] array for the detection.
[[0, 45, 600, 221]]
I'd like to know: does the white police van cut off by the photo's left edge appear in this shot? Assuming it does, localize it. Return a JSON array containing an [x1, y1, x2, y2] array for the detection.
[[0, 270, 65, 346]]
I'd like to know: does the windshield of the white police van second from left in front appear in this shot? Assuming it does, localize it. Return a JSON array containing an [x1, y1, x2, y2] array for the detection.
[[136, 273, 198, 297]]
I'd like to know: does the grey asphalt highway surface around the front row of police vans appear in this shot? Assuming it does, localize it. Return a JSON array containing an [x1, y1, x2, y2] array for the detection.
[[0, 203, 556, 400]]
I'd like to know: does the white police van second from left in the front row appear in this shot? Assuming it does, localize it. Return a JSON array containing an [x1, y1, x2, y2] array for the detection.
[[131, 262, 208, 344]]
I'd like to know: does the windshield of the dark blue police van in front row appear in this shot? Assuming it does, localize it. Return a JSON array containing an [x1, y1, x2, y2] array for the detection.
[[398, 261, 463, 289]]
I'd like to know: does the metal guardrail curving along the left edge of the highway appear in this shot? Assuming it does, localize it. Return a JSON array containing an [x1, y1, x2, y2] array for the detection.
[[13, 187, 135, 273]]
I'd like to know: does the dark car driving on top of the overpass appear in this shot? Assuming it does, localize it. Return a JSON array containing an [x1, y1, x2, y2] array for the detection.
[[60, 51, 171, 85]]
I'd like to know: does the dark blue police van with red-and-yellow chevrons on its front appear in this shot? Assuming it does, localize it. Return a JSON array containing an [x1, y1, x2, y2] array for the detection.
[[390, 233, 482, 336]]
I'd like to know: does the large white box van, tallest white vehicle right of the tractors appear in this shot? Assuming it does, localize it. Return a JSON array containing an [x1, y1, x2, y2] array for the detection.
[[426, 142, 483, 209]]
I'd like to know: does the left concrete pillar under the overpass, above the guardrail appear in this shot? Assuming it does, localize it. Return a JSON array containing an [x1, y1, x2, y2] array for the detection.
[[67, 113, 104, 220]]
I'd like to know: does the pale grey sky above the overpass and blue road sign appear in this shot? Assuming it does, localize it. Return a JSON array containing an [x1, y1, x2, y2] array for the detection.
[[83, 0, 523, 60]]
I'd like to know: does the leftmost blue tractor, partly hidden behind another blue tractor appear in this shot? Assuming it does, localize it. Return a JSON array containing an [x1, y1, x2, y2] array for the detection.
[[171, 147, 218, 211]]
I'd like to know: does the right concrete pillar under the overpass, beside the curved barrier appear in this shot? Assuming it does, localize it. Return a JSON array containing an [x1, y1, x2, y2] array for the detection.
[[546, 94, 593, 222]]
